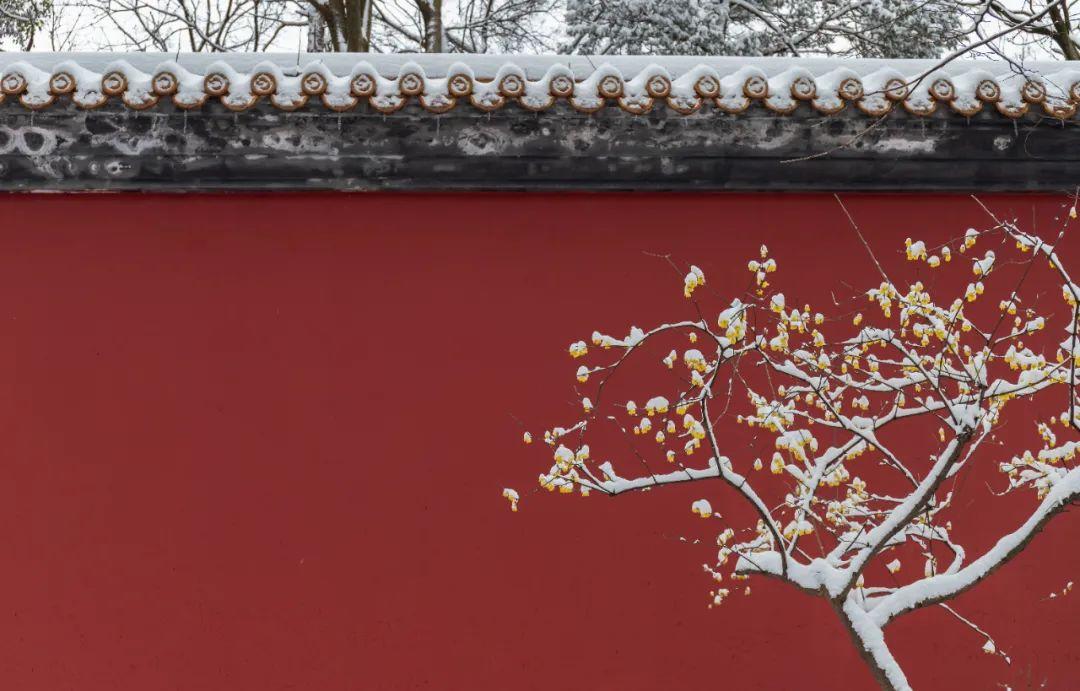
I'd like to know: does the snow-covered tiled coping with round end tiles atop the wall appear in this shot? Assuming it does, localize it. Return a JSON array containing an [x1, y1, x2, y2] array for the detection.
[[0, 53, 1080, 118]]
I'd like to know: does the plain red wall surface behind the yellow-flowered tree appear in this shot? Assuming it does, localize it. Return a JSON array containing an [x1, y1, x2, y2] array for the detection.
[[0, 194, 1080, 691]]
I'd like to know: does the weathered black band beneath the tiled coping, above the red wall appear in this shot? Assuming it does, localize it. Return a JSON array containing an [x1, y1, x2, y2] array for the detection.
[[0, 97, 1080, 192]]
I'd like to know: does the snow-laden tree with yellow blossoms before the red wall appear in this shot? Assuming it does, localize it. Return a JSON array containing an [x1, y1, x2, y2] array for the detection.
[[503, 200, 1080, 689]]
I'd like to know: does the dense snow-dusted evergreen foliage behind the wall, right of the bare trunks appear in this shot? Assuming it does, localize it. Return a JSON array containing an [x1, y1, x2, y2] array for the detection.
[[565, 0, 962, 57]]
